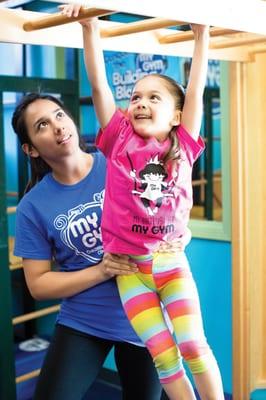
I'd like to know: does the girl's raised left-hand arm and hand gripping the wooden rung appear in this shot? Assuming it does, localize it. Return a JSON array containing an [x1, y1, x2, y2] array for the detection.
[[59, 4, 116, 128]]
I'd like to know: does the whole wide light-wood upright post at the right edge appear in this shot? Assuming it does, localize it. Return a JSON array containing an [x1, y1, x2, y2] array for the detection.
[[229, 50, 266, 400]]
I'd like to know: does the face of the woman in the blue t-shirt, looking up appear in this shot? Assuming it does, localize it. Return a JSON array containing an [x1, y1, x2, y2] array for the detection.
[[23, 99, 79, 163]]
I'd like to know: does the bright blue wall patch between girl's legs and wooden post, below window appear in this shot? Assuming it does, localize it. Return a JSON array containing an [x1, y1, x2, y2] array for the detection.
[[187, 239, 232, 393]]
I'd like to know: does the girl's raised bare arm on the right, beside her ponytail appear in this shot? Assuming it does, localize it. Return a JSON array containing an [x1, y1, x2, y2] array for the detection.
[[181, 24, 209, 140]]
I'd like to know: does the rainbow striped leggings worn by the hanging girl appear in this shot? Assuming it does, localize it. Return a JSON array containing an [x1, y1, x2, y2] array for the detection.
[[117, 252, 213, 383]]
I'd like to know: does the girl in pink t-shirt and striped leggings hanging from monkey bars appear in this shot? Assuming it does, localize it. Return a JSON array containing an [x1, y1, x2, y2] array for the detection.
[[62, 4, 224, 400]]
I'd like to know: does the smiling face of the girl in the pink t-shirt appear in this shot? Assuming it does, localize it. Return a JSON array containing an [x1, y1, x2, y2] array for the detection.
[[128, 75, 180, 141]]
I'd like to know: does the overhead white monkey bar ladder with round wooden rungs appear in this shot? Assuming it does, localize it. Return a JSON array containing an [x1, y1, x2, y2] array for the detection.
[[0, 0, 266, 61]]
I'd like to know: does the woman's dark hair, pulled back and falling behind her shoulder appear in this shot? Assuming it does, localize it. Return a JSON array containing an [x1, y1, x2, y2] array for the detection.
[[12, 93, 87, 193]]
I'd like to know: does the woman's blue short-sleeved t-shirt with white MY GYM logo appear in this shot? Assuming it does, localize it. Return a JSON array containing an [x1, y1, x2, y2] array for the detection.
[[14, 153, 141, 345]]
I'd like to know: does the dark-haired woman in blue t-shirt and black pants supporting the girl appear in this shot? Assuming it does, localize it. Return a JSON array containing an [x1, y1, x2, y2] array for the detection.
[[12, 93, 161, 400]]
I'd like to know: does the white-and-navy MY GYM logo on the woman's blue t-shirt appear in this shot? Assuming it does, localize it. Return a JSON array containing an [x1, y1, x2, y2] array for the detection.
[[54, 191, 104, 262]]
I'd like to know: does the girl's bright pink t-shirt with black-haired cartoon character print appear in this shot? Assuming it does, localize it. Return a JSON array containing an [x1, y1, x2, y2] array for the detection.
[[96, 110, 204, 255]]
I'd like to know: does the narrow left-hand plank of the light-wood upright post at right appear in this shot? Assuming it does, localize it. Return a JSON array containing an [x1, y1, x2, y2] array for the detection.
[[230, 63, 250, 400]]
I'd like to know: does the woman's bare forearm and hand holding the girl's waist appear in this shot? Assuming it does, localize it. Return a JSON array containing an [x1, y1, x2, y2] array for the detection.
[[23, 253, 137, 300]]
